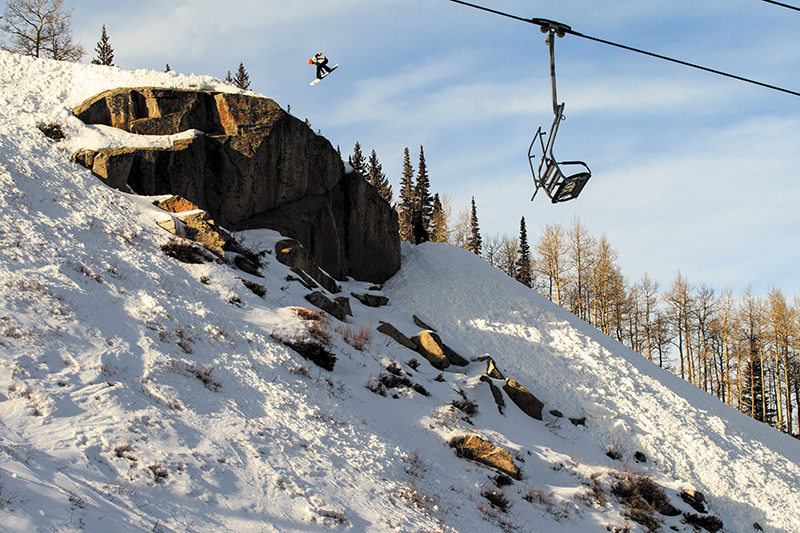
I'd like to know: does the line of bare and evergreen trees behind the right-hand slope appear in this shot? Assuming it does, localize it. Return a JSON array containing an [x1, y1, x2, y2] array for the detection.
[[350, 143, 800, 435]]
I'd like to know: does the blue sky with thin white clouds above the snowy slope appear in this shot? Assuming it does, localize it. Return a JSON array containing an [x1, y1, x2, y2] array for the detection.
[[67, 0, 800, 296]]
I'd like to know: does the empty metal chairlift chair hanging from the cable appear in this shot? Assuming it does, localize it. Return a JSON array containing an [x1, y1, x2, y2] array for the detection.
[[528, 21, 592, 204]]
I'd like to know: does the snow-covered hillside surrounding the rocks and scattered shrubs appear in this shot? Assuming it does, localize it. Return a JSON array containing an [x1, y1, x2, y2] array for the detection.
[[0, 52, 800, 533]]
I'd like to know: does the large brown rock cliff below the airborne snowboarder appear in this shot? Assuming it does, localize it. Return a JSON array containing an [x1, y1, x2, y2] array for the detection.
[[73, 87, 400, 283]]
